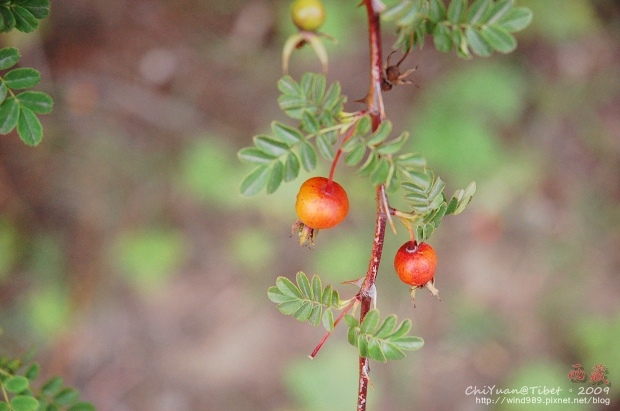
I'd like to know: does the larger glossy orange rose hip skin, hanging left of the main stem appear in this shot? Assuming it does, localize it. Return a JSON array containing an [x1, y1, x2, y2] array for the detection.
[[295, 177, 349, 229]]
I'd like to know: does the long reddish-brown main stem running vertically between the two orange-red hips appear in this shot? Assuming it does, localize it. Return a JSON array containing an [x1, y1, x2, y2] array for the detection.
[[357, 0, 387, 411]]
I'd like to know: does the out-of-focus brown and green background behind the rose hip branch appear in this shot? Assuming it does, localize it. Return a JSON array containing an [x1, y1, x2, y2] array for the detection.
[[0, 0, 620, 411]]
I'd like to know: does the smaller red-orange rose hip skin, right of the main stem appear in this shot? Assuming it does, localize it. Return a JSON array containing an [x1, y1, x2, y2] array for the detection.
[[394, 241, 437, 287]]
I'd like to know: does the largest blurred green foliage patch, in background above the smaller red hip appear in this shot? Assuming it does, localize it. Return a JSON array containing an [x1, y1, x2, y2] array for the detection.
[[412, 61, 527, 184]]
